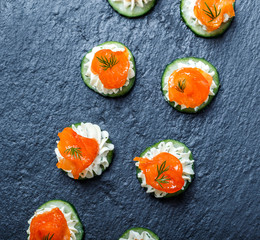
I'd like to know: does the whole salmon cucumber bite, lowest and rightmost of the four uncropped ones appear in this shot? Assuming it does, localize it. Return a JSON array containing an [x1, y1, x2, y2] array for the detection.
[[134, 139, 194, 198]]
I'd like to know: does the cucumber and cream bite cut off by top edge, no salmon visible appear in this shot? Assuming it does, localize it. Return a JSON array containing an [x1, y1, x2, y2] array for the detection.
[[108, 0, 156, 18]]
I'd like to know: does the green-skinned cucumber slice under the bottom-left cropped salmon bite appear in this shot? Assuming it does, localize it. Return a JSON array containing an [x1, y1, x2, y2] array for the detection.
[[29, 200, 84, 240]]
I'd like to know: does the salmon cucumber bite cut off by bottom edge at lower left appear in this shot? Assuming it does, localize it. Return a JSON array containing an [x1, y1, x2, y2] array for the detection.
[[27, 200, 84, 240]]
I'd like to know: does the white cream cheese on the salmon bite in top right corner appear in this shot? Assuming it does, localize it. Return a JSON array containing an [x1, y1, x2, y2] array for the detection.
[[182, 0, 230, 31]]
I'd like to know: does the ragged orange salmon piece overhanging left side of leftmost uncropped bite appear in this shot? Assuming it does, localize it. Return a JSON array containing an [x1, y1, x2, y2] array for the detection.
[[57, 127, 99, 179]]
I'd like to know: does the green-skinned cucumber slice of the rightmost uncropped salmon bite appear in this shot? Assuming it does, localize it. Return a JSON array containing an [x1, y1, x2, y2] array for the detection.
[[161, 57, 220, 113]]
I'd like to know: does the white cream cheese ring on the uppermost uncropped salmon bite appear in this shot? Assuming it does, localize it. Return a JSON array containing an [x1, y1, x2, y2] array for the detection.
[[84, 44, 135, 94]]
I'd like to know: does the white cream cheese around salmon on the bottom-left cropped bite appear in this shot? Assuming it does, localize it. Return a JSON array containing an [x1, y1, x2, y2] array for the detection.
[[27, 205, 78, 240]]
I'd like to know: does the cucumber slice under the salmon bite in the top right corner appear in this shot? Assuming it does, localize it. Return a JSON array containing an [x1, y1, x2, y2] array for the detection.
[[180, 0, 235, 38]]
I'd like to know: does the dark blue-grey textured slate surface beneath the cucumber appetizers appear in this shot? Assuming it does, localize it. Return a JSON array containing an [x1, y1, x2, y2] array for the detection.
[[0, 0, 260, 240]]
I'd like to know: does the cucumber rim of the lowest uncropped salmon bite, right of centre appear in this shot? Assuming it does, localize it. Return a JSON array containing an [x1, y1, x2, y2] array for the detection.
[[136, 139, 194, 198]]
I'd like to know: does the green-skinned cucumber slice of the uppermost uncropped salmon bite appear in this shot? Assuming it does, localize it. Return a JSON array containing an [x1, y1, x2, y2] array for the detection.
[[81, 41, 136, 97]]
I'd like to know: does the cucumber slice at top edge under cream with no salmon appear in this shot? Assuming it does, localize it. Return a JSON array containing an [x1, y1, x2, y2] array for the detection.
[[108, 0, 157, 18]]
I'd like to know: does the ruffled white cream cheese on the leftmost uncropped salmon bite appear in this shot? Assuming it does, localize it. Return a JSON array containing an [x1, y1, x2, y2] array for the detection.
[[55, 123, 114, 178]]
